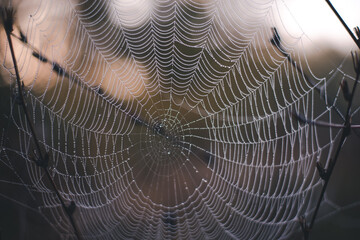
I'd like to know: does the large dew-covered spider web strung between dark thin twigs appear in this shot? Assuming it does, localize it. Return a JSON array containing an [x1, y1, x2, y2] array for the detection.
[[0, 0, 358, 239]]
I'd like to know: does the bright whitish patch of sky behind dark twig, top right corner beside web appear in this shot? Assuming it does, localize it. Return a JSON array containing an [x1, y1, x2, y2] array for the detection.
[[279, 0, 360, 51]]
